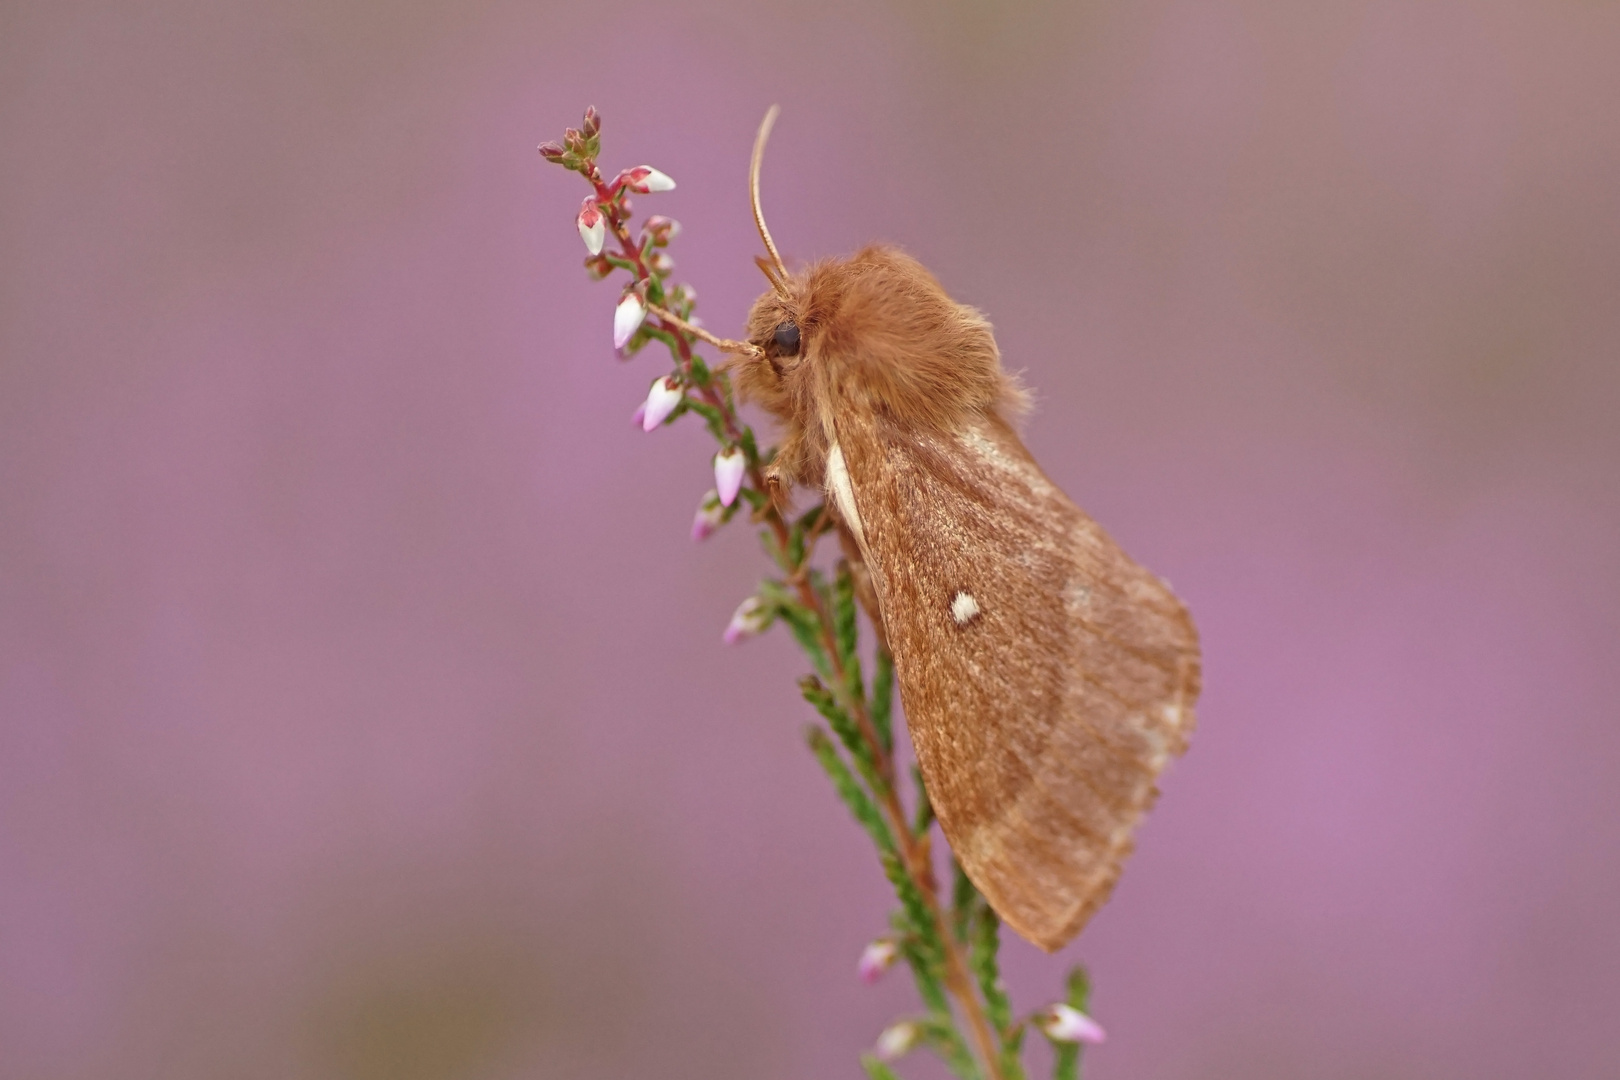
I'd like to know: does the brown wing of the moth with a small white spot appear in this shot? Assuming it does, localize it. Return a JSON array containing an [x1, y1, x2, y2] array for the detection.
[[828, 415, 1200, 950]]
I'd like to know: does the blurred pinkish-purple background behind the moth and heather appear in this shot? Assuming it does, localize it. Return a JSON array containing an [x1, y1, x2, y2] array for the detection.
[[0, 0, 1620, 1080]]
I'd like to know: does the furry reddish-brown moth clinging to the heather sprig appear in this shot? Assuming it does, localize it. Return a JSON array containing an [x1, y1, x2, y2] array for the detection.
[[729, 108, 1199, 950]]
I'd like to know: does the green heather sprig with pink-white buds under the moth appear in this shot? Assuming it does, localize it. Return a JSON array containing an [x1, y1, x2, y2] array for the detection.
[[539, 108, 1103, 1080]]
